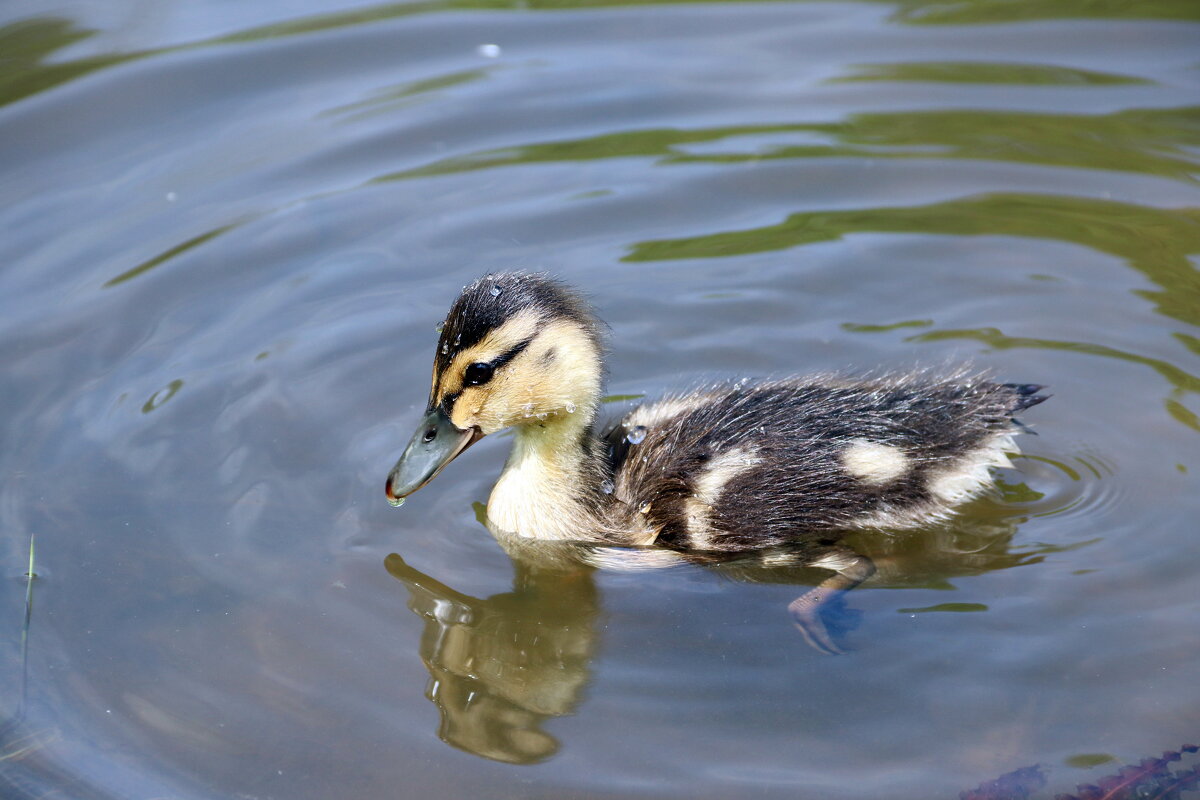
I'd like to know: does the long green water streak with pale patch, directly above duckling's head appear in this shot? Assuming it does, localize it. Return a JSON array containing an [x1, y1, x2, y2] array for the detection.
[[371, 106, 1200, 184]]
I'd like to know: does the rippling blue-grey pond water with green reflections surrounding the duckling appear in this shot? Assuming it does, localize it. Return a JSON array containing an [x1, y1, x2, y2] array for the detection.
[[0, 0, 1200, 800]]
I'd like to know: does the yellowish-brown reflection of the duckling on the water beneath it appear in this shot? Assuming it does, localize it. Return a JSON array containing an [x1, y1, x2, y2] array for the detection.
[[384, 517, 1054, 764]]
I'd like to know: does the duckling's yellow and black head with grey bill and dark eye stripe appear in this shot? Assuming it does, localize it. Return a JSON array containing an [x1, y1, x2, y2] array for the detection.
[[388, 272, 602, 503]]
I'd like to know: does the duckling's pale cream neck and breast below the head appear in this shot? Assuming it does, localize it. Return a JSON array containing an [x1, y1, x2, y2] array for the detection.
[[487, 408, 604, 541]]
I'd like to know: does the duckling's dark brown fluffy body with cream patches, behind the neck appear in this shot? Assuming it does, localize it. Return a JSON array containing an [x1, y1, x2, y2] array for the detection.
[[610, 374, 1045, 551]]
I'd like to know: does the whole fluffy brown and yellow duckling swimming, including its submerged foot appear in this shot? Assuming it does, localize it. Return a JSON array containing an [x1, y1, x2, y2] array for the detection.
[[386, 272, 1045, 652]]
